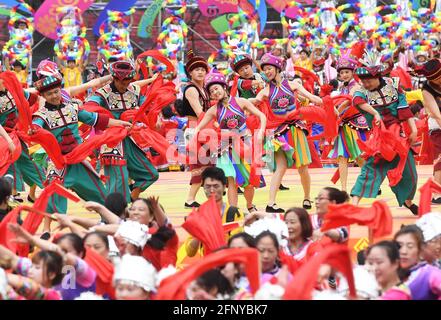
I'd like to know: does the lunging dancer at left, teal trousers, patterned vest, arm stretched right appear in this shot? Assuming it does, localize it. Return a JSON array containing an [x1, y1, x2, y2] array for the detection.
[[31, 76, 131, 222]]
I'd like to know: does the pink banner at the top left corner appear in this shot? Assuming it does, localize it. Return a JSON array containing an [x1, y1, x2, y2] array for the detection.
[[34, 0, 94, 40]]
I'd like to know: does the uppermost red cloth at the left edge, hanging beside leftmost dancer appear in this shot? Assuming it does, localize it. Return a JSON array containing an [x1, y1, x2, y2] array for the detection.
[[0, 71, 32, 131]]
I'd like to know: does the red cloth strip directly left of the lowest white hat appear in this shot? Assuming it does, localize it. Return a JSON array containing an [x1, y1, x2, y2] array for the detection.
[[84, 248, 115, 299]]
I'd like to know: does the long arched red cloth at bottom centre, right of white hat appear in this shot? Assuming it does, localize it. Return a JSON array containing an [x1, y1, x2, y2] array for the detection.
[[156, 248, 260, 300]]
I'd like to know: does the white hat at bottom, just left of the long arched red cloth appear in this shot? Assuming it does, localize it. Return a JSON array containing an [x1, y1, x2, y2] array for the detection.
[[113, 254, 156, 292]]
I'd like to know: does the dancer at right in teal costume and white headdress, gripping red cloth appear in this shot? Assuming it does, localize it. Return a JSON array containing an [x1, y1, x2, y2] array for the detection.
[[351, 50, 418, 215]]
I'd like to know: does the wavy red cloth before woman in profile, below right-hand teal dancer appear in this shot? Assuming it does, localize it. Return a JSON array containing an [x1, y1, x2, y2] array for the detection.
[[321, 200, 392, 237]]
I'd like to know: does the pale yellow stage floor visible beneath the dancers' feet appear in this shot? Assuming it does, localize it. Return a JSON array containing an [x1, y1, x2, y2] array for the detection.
[[33, 166, 438, 254]]
